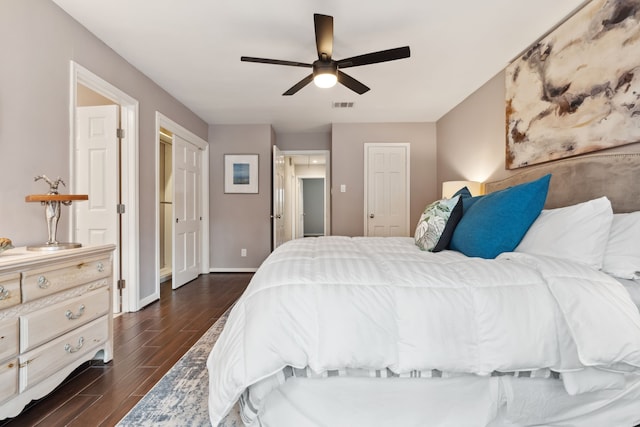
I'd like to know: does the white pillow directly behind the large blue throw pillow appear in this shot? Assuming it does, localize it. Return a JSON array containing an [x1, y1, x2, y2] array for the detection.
[[515, 197, 613, 269]]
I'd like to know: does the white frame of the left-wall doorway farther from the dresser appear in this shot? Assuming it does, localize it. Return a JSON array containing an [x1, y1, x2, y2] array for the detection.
[[154, 111, 209, 303]]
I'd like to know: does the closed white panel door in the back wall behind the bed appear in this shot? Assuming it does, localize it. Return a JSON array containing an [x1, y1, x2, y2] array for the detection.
[[365, 143, 409, 236]]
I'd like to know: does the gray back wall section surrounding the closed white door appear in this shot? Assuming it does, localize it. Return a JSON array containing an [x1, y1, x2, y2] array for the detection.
[[331, 123, 440, 236]]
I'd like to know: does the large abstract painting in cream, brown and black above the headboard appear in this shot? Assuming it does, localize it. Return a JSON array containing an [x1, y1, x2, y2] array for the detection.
[[505, 0, 640, 169]]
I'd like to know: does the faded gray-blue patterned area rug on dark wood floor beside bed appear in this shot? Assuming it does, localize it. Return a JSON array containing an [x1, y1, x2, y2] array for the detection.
[[117, 309, 243, 427]]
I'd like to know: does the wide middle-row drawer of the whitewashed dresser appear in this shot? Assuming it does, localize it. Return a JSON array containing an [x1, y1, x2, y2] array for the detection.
[[20, 287, 110, 353]]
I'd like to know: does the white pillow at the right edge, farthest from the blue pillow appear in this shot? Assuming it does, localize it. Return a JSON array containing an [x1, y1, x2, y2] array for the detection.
[[602, 211, 640, 279]]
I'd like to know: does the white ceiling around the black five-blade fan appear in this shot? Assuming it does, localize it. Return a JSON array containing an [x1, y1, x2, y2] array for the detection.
[[53, 0, 585, 132]]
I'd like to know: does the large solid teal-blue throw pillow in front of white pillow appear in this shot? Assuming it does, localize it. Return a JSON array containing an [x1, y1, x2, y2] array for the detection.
[[450, 175, 551, 258]]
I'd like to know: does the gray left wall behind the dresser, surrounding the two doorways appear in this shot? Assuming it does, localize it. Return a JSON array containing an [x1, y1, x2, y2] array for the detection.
[[0, 0, 208, 297]]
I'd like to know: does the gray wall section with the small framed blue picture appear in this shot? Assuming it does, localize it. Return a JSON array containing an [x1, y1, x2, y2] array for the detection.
[[209, 125, 275, 271]]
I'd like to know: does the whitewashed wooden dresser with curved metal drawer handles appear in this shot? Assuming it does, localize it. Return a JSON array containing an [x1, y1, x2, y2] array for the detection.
[[0, 245, 115, 420]]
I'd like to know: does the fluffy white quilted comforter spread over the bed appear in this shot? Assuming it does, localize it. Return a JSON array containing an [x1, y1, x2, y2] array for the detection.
[[207, 237, 640, 426]]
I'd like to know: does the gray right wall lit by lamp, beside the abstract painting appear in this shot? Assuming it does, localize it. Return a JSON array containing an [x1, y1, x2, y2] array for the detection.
[[437, 71, 640, 184]]
